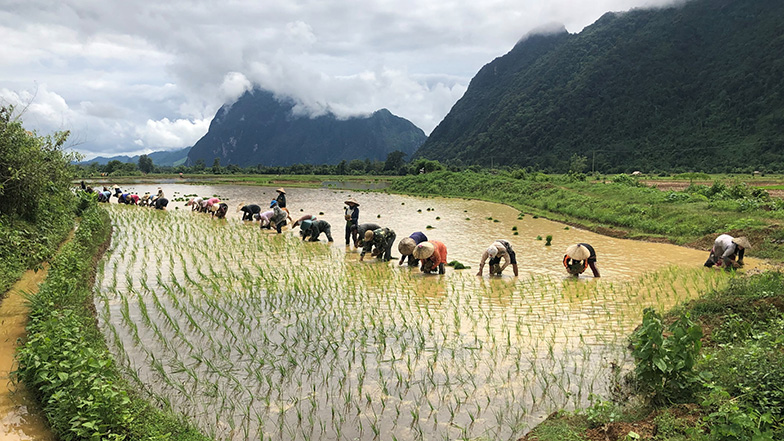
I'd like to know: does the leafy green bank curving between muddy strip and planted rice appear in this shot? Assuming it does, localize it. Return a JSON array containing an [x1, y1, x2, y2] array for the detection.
[[17, 203, 206, 440]]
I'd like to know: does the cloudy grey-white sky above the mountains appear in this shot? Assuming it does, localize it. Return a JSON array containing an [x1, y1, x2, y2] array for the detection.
[[0, 0, 671, 159]]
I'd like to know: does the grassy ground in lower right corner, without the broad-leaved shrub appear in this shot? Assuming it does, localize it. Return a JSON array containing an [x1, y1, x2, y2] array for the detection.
[[526, 272, 784, 441]]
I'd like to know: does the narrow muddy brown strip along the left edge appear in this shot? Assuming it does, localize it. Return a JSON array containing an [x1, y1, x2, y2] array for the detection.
[[0, 267, 55, 441]]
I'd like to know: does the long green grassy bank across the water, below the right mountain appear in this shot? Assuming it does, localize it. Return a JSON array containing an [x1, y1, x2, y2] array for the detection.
[[389, 171, 784, 260]]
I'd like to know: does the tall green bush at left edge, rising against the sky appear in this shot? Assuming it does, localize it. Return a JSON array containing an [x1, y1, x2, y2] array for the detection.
[[0, 106, 78, 220]]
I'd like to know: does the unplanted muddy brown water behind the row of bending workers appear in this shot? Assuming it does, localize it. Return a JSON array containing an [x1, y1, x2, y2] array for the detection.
[[107, 184, 768, 280]]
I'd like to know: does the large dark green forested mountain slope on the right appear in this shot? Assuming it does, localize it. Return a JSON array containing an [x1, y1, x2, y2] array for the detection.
[[415, 0, 784, 172]]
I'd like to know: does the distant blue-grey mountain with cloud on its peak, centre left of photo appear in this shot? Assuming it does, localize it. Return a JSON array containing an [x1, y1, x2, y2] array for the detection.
[[188, 89, 426, 166]]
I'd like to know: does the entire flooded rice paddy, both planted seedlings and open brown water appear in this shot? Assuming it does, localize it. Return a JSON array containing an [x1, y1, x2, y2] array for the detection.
[[96, 184, 761, 440]]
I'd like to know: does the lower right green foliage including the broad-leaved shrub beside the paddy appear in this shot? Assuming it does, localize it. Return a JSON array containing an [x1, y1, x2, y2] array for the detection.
[[526, 272, 784, 441]]
